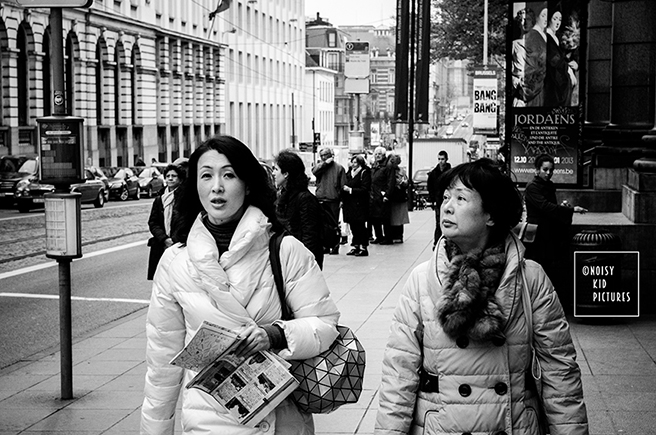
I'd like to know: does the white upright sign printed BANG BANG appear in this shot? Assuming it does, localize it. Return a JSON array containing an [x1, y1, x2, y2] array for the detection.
[[472, 66, 499, 134]]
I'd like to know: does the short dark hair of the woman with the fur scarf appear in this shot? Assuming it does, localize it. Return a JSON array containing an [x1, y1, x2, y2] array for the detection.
[[438, 158, 524, 243]]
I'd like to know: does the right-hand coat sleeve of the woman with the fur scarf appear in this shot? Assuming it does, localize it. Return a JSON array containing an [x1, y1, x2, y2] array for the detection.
[[526, 260, 588, 435]]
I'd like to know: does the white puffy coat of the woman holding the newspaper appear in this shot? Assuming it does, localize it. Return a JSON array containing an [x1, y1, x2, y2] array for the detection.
[[141, 207, 339, 435]]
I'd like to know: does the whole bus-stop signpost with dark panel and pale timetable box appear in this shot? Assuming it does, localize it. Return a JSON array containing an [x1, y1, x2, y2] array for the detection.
[[16, 0, 93, 400]]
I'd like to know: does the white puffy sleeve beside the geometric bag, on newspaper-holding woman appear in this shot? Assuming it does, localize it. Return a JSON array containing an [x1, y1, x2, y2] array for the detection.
[[274, 237, 340, 359]]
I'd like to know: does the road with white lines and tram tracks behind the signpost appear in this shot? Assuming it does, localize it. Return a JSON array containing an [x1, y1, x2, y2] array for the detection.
[[0, 200, 152, 368]]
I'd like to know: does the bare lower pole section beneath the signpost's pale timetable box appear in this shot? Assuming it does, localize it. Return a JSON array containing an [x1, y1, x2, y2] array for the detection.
[[57, 258, 73, 400]]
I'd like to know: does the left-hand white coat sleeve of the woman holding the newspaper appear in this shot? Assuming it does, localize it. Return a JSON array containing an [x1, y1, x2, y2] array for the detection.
[[141, 248, 186, 435]]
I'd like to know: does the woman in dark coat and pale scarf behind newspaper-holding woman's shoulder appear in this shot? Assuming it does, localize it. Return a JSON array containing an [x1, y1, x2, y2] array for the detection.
[[148, 165, 186, 280]]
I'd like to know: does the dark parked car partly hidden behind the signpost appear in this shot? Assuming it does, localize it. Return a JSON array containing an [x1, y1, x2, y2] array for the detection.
[[16, 168, 107, 213]]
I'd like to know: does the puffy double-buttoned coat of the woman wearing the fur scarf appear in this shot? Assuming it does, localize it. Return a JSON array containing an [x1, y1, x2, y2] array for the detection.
[[375, 235, 588, 435]]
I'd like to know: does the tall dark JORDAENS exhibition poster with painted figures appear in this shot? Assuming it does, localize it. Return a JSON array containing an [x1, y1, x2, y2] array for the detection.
[[506, 0, 585, 184]]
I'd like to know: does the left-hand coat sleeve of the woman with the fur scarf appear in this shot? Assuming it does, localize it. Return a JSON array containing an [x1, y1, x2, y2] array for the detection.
[[374, 263, 428, 435]]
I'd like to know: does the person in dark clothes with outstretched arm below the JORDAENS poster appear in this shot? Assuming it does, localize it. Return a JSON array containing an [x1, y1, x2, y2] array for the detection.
[[524, 154, 587, 303]]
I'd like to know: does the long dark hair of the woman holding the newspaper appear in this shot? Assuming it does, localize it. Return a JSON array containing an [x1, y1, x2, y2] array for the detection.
[[176, 136, 281, 243]]
